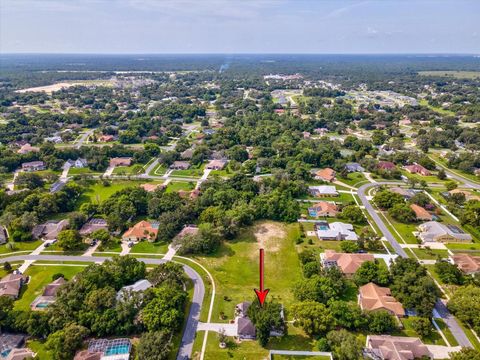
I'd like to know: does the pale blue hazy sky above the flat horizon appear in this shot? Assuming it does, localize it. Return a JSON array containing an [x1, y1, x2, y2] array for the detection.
[[0, 0, 480, 54]]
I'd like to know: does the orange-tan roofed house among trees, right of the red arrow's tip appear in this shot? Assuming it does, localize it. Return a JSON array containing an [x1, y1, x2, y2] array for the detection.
[[358, 283, 405, 317]]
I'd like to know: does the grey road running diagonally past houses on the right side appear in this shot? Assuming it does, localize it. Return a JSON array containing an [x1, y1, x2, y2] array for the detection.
[[358, 182, 473, 347]]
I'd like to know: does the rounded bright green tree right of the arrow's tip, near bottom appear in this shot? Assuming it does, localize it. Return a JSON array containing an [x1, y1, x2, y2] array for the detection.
[[292, 301, 335, 336]]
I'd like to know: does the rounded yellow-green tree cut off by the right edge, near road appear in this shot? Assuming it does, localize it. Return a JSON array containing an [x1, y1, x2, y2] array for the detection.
[[448, 285, 480, 332]]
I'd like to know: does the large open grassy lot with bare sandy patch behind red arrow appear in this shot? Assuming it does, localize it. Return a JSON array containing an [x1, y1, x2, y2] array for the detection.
[[190, 222, 302, 322]]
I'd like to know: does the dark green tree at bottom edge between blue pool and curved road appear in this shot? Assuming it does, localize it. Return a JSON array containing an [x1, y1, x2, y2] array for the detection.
[[137, 331, 172, 360]]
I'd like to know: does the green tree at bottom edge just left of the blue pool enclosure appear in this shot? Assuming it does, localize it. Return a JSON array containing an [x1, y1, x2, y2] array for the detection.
[[45, 324, 88, 360]]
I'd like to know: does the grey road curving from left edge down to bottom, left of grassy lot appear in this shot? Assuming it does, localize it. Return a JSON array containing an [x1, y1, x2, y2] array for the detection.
[[0, 255, 205, 360]]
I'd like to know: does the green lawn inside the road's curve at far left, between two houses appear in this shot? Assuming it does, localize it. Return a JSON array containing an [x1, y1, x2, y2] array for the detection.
[[15, 265, 84, 310]]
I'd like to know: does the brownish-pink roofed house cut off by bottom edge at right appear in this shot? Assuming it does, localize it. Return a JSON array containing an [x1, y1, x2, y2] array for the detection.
[[366, 335, 433, 360]]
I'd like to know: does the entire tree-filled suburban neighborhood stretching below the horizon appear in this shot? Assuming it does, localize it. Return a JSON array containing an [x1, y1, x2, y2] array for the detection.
[[0, 51, 480, 360]]
